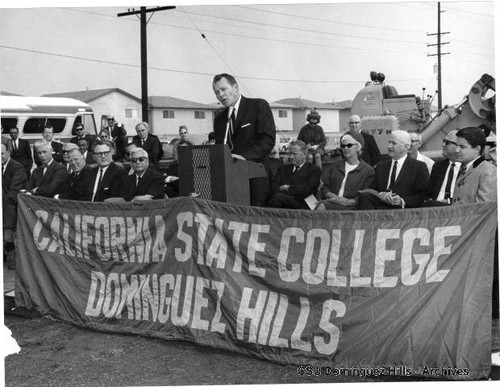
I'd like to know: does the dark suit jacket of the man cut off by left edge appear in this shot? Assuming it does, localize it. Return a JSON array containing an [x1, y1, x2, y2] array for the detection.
[[2, 158, 27, 230]]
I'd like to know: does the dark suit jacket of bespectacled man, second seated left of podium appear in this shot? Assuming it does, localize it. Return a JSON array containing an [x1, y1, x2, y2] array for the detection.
[[85, 162, 127, 202]]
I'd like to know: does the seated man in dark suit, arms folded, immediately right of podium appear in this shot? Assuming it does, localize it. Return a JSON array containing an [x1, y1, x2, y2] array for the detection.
[[270, 140, 321, 209]]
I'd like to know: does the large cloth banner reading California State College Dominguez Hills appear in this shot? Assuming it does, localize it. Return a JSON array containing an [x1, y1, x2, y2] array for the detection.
[[16, 195, 497, 379]]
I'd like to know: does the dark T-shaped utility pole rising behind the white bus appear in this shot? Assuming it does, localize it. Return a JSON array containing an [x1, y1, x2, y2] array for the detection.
[[116, 6, 175, 122]]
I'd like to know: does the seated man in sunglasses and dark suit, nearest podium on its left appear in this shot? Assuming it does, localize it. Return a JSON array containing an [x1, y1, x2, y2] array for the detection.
[[127, 148, 165, 202]]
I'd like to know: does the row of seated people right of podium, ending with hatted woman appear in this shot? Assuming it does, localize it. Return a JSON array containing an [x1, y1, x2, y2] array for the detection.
[[270, 127, 497, 210]]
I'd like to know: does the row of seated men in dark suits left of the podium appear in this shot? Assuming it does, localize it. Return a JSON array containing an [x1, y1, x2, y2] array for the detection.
[[2, 140, 165, 202]]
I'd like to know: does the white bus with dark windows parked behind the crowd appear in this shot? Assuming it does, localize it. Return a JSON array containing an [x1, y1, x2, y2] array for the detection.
[[0, 95, 98, 144]]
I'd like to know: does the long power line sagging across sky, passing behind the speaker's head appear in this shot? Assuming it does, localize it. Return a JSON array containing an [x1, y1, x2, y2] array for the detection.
[[0, 45, 430, 83]]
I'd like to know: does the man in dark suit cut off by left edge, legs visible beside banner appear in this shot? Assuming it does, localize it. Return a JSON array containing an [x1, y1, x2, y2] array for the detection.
[[2, 144, 26, 269]]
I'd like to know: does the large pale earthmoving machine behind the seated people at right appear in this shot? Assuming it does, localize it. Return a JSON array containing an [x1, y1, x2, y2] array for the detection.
[[351, 71, 496, 158]]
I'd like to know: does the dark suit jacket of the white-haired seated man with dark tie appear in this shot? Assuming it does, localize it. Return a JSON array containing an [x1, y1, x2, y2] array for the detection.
[[372, 156, 429, 208]]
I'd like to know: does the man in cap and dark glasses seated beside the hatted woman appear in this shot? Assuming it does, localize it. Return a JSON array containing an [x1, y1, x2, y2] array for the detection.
[[424, 130, 461, 207]]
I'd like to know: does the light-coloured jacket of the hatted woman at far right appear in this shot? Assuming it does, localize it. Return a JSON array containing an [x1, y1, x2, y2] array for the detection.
[[453, 157, 497, 204]]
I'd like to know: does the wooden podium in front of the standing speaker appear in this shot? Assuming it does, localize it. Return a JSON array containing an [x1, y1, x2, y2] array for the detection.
[[177, 144, 267, 205]]
